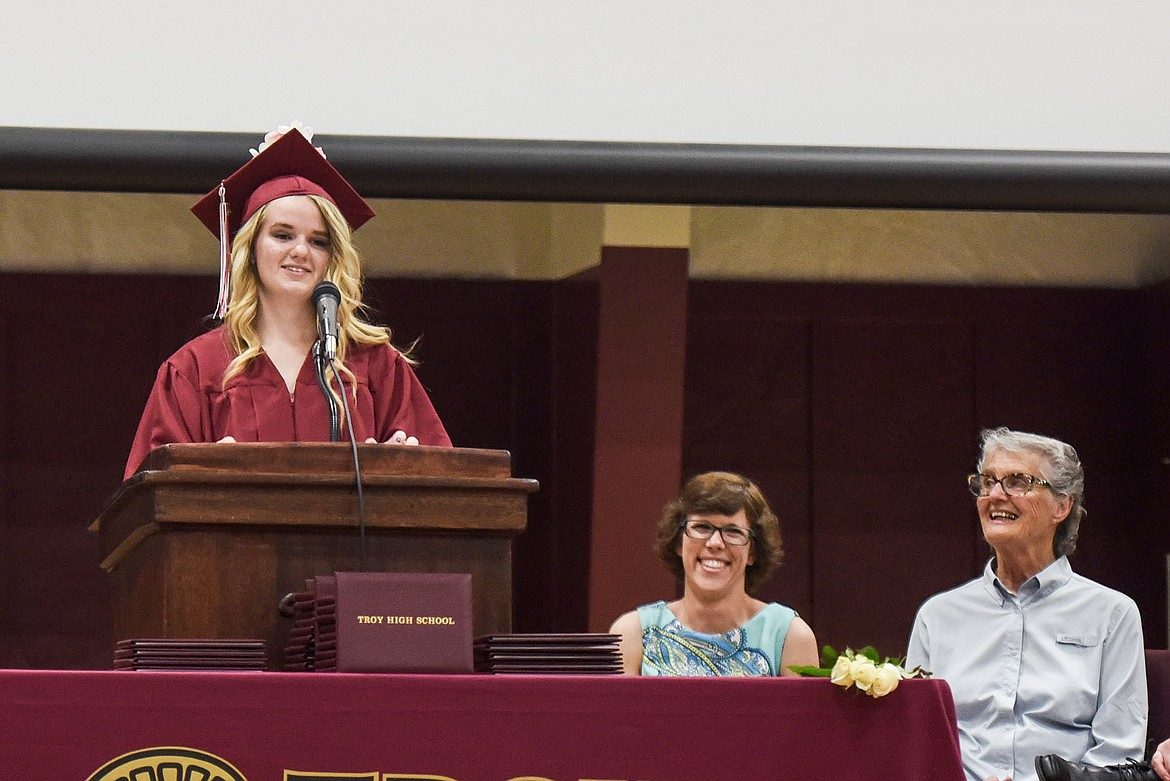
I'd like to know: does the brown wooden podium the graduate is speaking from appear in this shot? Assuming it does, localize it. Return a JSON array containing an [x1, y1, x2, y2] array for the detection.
[[90, 442, 537, 669]]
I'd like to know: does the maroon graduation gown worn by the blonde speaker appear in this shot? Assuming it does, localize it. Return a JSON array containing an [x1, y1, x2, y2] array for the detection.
[[125, 326, 450, 477]]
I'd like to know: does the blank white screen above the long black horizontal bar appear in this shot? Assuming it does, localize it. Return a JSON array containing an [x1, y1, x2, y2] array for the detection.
[[0, 0, 1170, 152]]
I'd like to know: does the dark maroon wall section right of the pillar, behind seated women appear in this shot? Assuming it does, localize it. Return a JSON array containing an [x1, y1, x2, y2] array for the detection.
[[684, 282, 1170, 654]]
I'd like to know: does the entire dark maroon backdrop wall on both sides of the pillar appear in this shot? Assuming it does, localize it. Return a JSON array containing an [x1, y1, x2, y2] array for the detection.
[[0, 272, 1170, 669]]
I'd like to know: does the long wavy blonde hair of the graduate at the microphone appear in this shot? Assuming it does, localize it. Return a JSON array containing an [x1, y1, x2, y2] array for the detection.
[[222, 194, 414, 414]]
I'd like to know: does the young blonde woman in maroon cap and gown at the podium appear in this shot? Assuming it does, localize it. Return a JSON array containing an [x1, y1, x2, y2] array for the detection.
[[125, 127, 450, 477]]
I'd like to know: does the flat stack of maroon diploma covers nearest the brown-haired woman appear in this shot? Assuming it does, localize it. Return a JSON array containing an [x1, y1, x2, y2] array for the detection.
[[475, 634, 621, 675]]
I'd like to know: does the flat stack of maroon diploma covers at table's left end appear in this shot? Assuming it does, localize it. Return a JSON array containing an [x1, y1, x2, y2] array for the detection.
[[113, 638, 268, 672]]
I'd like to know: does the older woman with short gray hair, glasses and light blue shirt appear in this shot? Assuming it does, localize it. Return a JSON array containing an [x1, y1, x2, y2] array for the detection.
[[907, 428, 1147, 781]]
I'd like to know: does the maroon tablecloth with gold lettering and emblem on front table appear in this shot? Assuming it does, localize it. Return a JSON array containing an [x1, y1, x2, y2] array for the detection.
[[0, 670, 963, 781]]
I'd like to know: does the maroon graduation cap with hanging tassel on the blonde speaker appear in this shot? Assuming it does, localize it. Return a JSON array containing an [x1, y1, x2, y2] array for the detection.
[[191, 127, 373, 318]]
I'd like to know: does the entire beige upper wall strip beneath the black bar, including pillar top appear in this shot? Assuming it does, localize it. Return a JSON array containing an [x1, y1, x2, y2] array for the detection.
[[0, 191, 1170, 288]]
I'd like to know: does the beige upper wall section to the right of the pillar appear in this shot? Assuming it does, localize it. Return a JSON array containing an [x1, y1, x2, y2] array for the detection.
[[691, 208, 1170, 288]]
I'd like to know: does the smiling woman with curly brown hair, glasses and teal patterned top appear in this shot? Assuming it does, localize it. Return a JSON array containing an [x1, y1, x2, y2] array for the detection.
[[610, 472, 819, 676]]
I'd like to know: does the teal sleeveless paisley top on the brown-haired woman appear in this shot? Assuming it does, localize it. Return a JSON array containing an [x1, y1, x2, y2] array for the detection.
[[638, 601, 797, 676]]
